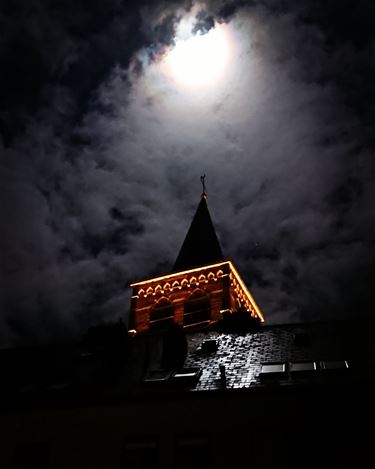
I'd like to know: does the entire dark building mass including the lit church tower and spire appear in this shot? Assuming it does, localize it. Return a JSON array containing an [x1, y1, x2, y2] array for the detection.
[[0, 188, 375, 469]]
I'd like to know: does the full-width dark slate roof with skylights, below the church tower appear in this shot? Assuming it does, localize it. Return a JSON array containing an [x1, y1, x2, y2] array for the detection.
[[0, 322, 375, 407]]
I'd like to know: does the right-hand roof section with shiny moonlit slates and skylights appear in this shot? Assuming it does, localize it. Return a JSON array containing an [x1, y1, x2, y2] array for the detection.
[[144, 323, 375, 391]]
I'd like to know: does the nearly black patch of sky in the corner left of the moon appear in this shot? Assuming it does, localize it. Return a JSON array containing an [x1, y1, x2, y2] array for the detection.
[[0, 0, 188, 144]]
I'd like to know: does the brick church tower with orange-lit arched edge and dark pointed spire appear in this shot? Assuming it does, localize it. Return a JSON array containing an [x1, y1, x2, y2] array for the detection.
[[129, 177, 264, 334]]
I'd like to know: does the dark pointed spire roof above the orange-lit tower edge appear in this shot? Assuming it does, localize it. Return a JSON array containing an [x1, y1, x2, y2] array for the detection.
[[173, 194, 224, 272]]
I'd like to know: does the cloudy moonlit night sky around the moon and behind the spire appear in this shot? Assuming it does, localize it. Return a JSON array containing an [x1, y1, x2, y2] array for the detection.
[[0, 0, 375, 346]]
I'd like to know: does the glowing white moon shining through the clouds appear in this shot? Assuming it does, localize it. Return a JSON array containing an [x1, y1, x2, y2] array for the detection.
[[164, 25, 230, 88]]
